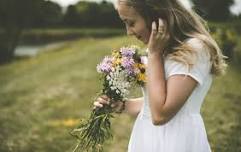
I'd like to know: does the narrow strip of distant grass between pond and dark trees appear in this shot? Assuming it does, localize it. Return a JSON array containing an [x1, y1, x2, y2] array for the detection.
[[18, 28, 125, 44]]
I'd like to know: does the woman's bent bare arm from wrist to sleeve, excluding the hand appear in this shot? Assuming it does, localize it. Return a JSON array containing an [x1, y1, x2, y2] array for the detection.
[[147, 54, 197, 125]]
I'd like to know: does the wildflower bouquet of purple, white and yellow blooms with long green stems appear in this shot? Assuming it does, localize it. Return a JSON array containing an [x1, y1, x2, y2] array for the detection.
[[71, 46, 146, 152]]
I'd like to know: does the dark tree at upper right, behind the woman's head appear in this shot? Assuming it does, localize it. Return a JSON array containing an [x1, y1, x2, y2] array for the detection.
[[192, 0, 234, 21]]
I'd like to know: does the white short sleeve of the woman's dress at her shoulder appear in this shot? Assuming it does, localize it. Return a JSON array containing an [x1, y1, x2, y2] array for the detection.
[[165, 40, 211, 85]]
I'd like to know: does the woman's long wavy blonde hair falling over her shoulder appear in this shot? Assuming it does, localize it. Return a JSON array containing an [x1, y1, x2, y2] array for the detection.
[[118, 0, 227, 75]]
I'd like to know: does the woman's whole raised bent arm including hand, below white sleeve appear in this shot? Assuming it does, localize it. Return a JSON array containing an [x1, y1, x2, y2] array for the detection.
[[147, 19, 197, 125]]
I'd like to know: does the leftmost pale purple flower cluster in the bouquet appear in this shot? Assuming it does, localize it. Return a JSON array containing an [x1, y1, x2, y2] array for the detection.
[[96, 56, 113, 73]]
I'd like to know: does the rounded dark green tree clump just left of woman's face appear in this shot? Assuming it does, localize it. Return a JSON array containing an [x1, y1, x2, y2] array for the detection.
[[64, 1, 122, 27]]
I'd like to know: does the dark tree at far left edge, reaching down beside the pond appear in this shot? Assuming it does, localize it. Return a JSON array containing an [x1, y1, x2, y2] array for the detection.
[[0, 0, 44, 63]]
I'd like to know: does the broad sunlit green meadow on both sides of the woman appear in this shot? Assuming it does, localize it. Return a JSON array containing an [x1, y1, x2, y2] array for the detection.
[[0, 37, 241, 152]]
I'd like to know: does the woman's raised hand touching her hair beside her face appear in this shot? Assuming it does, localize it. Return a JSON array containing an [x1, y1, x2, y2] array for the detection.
[[148, 18, 170, 55]]
